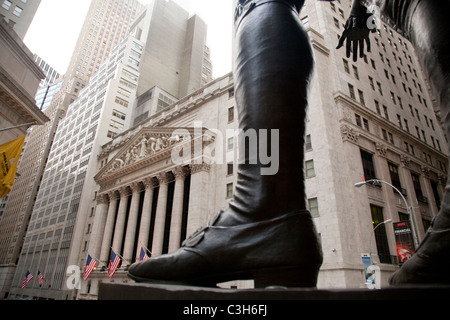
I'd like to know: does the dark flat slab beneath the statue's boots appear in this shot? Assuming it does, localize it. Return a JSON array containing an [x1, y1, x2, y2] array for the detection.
[[98, 283, 450, 301]]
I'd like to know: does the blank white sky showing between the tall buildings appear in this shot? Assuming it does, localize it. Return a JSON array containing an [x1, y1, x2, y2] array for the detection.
[[24, 0, 234, 77]]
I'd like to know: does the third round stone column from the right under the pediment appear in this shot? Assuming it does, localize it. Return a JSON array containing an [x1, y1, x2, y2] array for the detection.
[[136, 178, 157, 259]]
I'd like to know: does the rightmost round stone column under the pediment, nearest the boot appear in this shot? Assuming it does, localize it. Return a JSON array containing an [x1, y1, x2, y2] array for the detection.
[[169, 167, 189, 252]]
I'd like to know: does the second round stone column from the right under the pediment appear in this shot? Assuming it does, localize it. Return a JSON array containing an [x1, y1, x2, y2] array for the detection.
[[152, 173, 169, 257]]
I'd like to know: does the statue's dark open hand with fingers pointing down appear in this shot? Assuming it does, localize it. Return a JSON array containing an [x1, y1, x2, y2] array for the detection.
[[336, 14, 376, 61]]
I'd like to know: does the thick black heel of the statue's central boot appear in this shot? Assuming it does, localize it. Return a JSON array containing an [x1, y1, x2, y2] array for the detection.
[[252, 266, 319, 289]]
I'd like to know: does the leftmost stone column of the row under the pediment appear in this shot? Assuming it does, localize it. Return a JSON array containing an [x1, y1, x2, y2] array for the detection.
[[89, 194, 109, 257]]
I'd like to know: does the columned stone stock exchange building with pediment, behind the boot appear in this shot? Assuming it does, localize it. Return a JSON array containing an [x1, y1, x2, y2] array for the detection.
[[78, 74, 245, 299]]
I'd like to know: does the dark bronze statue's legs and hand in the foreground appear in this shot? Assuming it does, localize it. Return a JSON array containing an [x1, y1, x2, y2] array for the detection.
[[128, 0, 450, 288]]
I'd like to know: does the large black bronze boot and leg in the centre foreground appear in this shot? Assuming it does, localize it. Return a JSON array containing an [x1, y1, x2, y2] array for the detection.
[[128, 1, 322, 288]]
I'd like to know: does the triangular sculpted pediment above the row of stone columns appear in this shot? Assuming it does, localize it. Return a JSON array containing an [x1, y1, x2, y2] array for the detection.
[[94, 127, 213, 184]]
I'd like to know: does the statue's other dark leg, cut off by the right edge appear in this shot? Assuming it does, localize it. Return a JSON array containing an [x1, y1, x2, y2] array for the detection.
[[390, 0, 450, 285]]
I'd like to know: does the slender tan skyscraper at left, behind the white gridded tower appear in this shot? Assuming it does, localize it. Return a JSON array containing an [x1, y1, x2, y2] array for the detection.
[[0, 0, 143, 300]]
